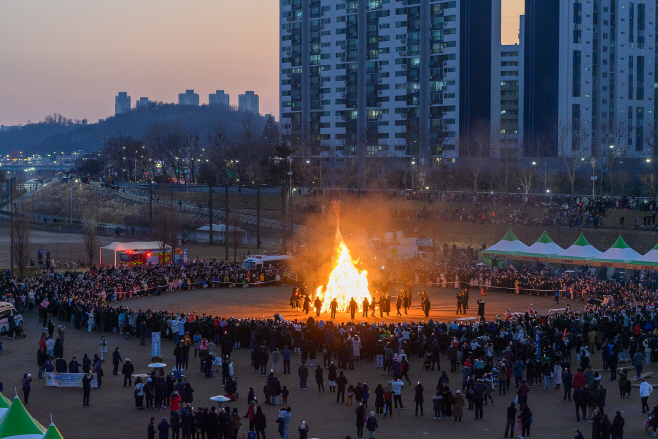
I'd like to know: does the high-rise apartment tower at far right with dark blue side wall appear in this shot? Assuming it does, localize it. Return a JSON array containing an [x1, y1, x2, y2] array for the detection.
[[524, 0, 658, 157]]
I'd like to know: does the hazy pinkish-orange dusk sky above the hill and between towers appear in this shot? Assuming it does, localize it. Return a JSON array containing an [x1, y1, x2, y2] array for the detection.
[[0, 0, 524, 125]]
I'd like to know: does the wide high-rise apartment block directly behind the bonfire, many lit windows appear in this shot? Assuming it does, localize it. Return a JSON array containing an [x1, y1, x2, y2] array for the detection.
[[280, 0, 492, 188]]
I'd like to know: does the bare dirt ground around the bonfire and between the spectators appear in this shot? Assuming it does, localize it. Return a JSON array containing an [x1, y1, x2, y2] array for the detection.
[[0, 287, 644, 439]]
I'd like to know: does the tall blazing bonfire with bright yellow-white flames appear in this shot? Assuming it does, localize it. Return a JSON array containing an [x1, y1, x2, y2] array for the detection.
[[316, 202, 371, 312]]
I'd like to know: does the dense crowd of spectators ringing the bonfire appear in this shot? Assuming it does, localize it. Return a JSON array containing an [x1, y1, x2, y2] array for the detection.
[[6, 252, 658, 439]]
